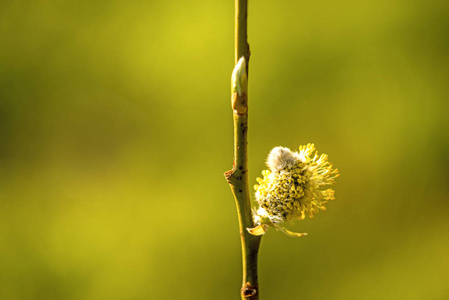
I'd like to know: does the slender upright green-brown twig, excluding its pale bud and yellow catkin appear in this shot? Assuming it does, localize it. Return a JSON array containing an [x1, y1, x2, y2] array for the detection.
[[225, 0, 261, 300]]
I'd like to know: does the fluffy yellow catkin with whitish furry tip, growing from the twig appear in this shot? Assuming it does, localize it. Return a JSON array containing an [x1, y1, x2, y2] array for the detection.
[[248, 144, 339, 237]]
